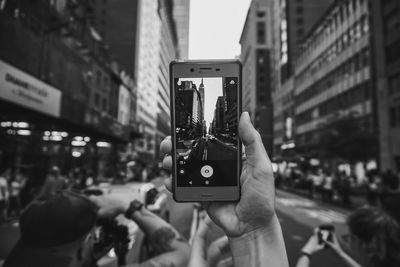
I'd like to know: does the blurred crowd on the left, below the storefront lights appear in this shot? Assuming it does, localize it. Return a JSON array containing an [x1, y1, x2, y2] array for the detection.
[[0, 164, 159, 227]]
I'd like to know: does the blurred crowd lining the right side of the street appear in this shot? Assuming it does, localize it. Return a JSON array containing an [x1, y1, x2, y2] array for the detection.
[[275, 167, 400, 209]]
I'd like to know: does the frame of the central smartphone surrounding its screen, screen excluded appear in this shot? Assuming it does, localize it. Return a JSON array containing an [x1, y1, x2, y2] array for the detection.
[[170, 60, 242, 202]]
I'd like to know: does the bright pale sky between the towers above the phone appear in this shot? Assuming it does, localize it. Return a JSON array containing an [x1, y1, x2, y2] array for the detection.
[[189, 0, 251, 59]]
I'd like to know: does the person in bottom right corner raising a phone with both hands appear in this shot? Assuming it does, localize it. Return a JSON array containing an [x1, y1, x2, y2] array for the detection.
[[296, 207, 400, 267]]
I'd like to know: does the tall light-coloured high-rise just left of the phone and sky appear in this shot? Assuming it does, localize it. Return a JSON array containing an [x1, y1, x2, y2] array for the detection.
[[135, 0, 177, 161]]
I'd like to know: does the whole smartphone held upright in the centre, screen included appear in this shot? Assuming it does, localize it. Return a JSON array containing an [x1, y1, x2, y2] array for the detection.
[[170, 60, 242, 202]]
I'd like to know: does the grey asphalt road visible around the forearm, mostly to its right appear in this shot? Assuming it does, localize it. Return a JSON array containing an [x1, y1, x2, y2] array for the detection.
[[167, 191, 360, 267]]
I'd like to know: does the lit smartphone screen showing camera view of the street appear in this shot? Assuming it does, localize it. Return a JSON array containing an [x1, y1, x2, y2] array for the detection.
[[174, 77, 238, 186]]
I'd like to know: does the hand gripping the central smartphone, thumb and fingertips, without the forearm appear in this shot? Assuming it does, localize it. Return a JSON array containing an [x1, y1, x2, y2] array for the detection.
[[160, 112, 279, 237]]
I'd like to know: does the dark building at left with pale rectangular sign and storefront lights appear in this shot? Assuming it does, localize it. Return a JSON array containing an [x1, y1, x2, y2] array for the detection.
[[0, 0, 138, 183]]
